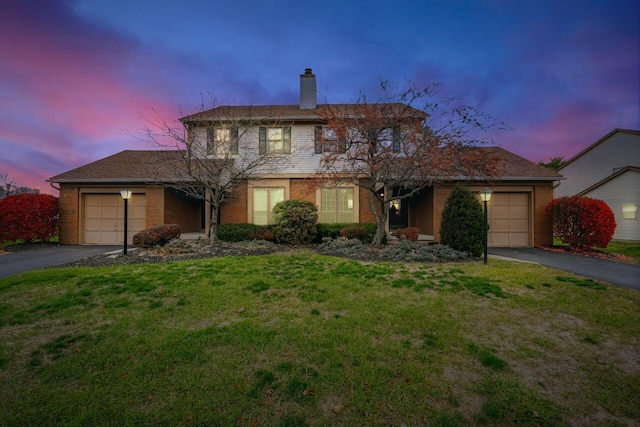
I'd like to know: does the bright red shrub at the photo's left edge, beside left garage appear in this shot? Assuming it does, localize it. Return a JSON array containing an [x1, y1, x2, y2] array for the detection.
[[0, 194, 58, 242]]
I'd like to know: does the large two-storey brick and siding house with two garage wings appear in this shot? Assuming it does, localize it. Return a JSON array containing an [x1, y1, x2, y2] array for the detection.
[[49, 69, 562, 246]]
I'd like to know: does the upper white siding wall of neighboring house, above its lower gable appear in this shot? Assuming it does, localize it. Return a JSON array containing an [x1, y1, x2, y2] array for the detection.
[[555, 131, 640, 197]]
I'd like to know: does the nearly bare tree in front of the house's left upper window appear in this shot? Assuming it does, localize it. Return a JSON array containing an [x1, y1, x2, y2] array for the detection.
[[140, 101, 293, 243]]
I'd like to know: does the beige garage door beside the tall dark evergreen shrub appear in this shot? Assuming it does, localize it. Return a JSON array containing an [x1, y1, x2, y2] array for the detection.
[[488, 193, 530, 246]]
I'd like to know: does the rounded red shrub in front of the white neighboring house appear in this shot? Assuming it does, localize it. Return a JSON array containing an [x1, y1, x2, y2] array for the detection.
[[547, 196, 616, 250]]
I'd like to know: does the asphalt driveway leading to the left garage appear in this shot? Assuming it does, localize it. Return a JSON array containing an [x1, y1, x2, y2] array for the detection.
[[0, 245, 116, 278]]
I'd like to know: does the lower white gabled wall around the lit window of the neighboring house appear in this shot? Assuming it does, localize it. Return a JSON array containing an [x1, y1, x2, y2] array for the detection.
[[584, 170, 640, 241]]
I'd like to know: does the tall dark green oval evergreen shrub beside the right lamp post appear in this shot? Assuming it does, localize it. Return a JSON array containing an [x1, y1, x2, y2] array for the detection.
[[440, 185, 484, 256]]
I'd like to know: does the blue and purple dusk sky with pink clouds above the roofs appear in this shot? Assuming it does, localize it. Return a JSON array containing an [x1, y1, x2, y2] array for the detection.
[[0, 0, 640, 195]]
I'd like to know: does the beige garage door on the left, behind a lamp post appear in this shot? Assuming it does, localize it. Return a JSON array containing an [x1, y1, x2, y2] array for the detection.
[[84, 194, 146, 245]]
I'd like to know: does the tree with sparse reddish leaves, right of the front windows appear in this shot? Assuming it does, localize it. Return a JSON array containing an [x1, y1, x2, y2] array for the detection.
[[316, 82, 502, 245]]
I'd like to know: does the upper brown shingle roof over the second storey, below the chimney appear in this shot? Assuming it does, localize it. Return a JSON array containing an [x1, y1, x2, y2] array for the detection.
[[180, 103, 427, 123]]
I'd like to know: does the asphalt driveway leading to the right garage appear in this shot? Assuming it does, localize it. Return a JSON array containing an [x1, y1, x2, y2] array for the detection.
[[489, 248, 640, 290]]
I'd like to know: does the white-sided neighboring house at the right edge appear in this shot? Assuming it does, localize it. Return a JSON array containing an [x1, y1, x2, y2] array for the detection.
[[555, 129, 640, 242]]
